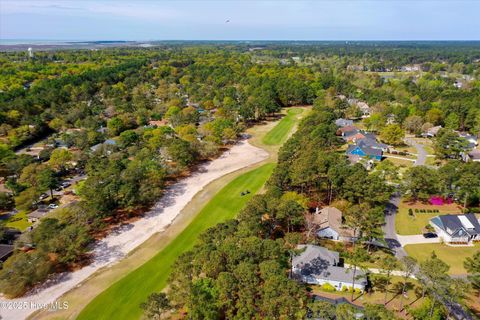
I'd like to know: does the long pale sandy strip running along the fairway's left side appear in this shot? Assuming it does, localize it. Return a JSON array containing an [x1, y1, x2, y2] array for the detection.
[[0, 140, 269, 320]]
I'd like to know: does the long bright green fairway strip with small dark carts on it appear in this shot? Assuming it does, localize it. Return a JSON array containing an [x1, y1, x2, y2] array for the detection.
[[78, 163, 275, 320]]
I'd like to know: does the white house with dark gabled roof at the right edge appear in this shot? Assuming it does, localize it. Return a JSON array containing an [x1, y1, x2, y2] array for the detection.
[[430, 213, 480, 244]]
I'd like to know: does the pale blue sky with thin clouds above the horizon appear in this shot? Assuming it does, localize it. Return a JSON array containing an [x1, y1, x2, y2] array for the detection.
[[0, 0, 480, 40]]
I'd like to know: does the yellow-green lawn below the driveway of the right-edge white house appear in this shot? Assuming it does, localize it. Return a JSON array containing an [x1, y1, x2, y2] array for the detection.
[[405, 243, 480, 274]]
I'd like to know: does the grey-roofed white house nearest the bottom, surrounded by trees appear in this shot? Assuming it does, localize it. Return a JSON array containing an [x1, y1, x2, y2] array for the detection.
[[292, 245, 367, 291]]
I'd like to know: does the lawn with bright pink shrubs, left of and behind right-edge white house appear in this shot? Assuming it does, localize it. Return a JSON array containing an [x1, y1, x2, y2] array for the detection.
[[395, 201, 462, 235]]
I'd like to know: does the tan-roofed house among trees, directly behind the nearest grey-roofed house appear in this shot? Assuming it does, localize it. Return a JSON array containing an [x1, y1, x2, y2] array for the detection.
[[313, 207, 357, 242]]
